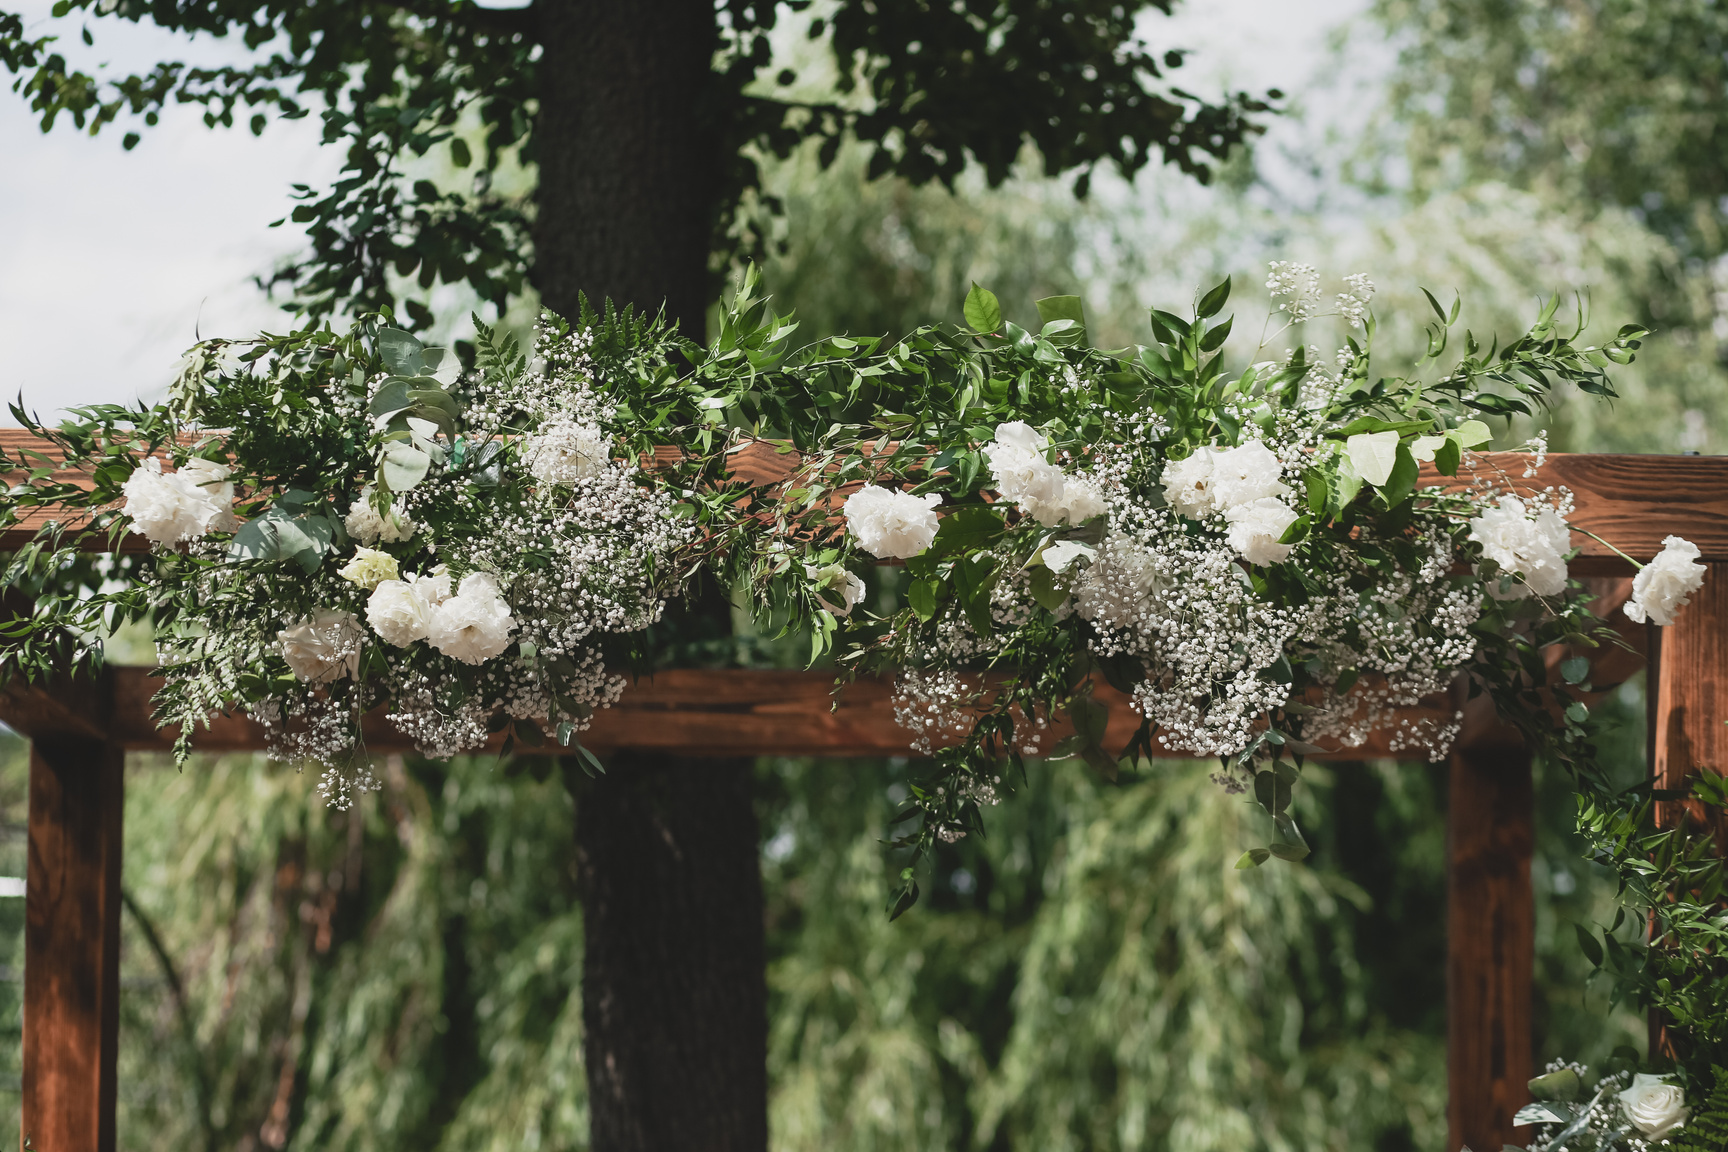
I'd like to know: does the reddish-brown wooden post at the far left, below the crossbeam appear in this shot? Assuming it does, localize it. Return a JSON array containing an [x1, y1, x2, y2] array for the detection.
[[21, 732, 124, 1152]]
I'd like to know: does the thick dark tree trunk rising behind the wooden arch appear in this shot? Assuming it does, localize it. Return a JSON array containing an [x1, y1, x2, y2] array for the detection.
[[534, 0, 767, 1152]]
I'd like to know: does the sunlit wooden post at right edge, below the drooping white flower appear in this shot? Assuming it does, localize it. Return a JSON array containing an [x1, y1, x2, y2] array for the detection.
[[1650, 563, 1728, 1057]]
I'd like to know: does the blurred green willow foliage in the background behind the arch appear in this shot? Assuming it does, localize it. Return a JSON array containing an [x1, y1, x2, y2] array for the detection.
[[0, 0, 1728, 1152]]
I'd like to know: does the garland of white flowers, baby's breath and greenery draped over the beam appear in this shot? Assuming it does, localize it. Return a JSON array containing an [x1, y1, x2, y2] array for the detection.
[[0, 264, 1721, 1091]]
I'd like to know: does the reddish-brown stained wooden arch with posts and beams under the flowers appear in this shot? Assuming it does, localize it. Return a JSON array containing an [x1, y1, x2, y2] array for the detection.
[[0, 430, 1728, 1152]]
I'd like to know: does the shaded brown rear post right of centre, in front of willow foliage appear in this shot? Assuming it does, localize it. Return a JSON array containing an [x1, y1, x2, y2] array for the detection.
[[1446, 737, 1536, 1152]]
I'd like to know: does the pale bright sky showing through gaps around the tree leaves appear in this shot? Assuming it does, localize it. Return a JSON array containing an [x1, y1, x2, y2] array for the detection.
[[0, 0, 1367, 425]]
